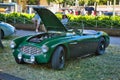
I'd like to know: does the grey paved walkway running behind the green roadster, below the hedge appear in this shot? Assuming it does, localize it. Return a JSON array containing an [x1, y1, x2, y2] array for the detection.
[[15, 30, 120, 45]]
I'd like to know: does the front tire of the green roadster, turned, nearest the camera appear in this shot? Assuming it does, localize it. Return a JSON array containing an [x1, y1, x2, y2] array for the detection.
[[51, 46, 65, 70]]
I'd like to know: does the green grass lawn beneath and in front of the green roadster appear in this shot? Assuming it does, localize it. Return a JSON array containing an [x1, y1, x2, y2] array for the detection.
[[0, 38, 120, 80]]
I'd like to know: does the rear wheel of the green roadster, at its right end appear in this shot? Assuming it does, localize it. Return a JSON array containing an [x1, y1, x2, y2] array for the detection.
[[96, 37, 105, 55]]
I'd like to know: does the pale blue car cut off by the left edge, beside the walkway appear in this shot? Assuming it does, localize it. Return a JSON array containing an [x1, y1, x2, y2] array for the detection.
[[0, 21, 15, 38]]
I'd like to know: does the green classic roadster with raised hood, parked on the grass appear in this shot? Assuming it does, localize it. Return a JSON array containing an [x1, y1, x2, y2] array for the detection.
[[11, 7, 109, 69]]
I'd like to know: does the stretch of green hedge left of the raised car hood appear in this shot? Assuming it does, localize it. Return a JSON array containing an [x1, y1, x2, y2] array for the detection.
[[0, 13, 34, 24]]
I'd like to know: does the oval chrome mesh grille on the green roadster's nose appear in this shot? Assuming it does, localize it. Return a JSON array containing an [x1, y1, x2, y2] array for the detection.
[[20, 46, 42, 54]]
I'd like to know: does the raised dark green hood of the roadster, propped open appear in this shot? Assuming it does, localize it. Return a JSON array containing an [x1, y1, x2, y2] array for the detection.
[[33, 7, 67, 32]]
